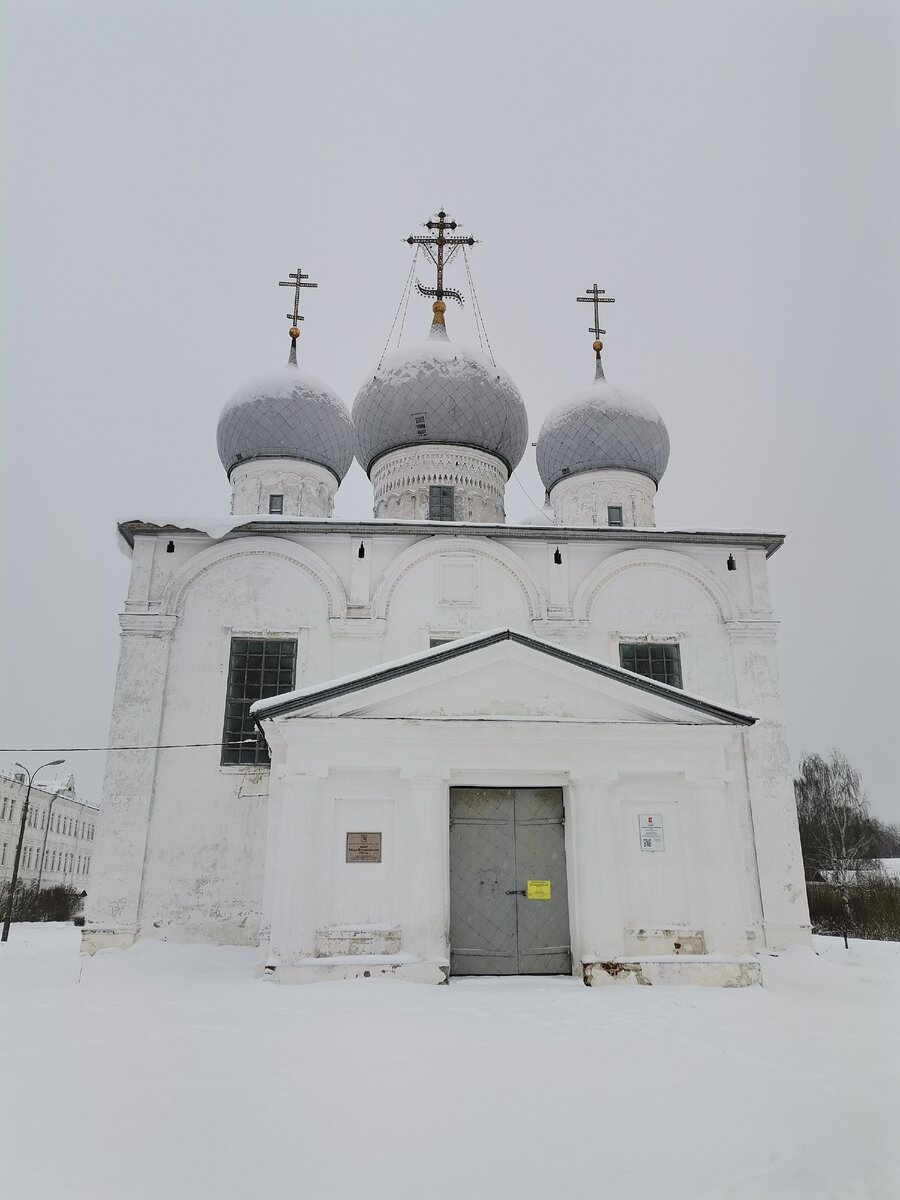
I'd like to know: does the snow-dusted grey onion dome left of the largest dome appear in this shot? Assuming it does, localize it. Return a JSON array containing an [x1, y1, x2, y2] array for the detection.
[[216, 365, 353, 482]]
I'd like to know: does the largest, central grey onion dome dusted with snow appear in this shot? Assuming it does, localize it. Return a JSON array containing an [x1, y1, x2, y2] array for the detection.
[[353, 326, 528, 473]]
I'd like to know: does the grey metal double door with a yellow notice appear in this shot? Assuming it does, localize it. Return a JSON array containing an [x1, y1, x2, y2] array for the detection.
[[450, 787, 571, 974]]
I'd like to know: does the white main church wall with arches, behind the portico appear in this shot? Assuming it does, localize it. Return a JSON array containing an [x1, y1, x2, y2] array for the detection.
[[86, 527, 809, 946]]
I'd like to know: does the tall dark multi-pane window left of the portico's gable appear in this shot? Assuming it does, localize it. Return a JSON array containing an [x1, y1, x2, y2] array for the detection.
[[222, 637, 296, 766]]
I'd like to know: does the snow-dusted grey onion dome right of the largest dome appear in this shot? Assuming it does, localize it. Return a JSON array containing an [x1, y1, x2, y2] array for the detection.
[[538, 378, 668, 491]]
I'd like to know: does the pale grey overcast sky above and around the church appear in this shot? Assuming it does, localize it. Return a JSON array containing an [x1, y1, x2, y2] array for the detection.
[[0, 0, 900, 820]]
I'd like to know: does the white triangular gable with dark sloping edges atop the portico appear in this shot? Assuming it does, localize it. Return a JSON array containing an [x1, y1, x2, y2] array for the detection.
[[251, 629, 756, 725]]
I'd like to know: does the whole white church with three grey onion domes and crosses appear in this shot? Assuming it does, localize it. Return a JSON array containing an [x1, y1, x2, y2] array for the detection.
[[84, 212, 810, 985]]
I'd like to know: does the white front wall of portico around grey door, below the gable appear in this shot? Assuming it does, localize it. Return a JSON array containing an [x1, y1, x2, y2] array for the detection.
[[264, 718, 761, 972]]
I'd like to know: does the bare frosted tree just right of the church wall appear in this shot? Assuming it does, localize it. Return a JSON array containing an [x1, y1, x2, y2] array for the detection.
[[793, 750, 872, 944]]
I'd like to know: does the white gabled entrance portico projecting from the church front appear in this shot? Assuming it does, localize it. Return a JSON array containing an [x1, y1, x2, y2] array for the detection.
[[254, 630, 762, 983]]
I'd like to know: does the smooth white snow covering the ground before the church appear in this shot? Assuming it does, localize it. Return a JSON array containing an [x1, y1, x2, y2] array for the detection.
[[0, 925, 900, 1200]]
